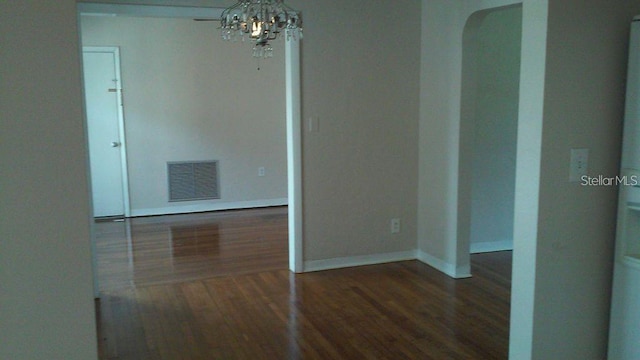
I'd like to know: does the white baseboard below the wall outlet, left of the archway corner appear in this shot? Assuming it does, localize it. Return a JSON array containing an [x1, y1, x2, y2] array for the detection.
[[304, 250, 416, 272]]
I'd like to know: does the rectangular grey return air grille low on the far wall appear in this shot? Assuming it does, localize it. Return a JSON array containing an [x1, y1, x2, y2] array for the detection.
[[167, 161, 220, 201]]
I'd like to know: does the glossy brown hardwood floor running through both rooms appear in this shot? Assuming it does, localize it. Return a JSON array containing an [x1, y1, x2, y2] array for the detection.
[[97, 208, 511, 360]]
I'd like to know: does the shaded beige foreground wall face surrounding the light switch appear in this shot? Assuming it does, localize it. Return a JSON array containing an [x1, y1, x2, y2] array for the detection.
[[532, 0, 640, 359]]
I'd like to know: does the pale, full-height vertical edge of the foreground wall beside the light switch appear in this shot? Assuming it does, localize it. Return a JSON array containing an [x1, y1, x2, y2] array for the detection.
[[509, 0, 548, 360]]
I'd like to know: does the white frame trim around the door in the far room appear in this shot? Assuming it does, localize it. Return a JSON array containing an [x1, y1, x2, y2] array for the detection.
[[82, 46, 131, 217]]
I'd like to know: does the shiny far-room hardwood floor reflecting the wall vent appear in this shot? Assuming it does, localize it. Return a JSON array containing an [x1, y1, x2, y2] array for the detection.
[[94, 207, 288, 291]]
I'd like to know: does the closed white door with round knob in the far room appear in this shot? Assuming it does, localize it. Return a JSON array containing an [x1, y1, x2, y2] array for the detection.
[[83, 47, 128, 217]]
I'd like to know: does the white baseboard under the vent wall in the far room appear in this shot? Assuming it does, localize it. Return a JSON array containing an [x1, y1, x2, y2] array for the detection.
[[131, 198, 289, 217]]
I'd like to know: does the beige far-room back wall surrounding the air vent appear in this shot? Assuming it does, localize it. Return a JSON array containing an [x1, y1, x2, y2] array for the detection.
[[81, 16, 287, 216]]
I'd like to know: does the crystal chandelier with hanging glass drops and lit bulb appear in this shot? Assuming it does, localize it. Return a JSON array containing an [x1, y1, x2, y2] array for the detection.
[[220, 0, 302, 58]]
